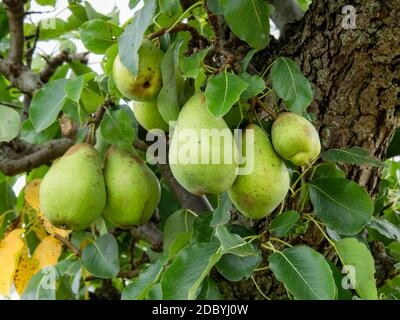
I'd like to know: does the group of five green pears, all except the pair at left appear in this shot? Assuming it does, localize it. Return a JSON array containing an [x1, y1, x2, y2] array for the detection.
[[113, 40, 321, 219]]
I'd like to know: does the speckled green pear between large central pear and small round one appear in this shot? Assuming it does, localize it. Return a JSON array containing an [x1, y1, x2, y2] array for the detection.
[[228, 124, 290, 219]]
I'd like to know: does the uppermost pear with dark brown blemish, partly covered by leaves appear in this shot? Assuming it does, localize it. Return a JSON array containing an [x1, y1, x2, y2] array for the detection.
[[113, 40, 163, 101]]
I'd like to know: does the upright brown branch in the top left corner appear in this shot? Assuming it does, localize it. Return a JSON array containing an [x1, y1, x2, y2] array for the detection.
[[3, 0, 25, 66]]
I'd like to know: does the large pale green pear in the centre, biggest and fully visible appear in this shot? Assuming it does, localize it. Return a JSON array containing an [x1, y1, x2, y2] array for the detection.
[[169, 93, 239, 195]]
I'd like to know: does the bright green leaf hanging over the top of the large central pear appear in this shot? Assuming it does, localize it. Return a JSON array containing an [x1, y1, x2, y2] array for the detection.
[[205, 69, 249, 117]]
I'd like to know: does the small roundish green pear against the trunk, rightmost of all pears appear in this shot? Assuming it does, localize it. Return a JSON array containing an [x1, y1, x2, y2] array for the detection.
[[271, 112, 321, 166]]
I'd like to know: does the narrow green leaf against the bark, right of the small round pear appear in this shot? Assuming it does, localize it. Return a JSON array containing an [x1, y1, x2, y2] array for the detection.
[[321, 147, 386, 167]]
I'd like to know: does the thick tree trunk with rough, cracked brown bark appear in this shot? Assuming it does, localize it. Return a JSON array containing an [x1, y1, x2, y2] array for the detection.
[[217, 0, 400, 299]]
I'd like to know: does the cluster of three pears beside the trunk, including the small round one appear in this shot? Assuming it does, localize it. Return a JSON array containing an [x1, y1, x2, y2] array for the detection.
[[170, 93, 321, 219]]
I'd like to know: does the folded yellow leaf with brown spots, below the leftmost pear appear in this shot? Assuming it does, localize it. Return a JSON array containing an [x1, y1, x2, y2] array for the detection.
[[14, 236, 62, 295]]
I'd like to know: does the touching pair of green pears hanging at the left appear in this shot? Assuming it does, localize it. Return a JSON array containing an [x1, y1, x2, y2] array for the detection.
[[39, 143, 161, 230]]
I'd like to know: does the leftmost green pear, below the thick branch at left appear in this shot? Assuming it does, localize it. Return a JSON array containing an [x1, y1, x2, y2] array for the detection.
[[39, 143, 106, 230]]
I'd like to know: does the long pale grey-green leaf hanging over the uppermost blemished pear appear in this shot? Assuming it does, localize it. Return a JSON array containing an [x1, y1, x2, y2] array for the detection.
[[118, 0, 156, 76]]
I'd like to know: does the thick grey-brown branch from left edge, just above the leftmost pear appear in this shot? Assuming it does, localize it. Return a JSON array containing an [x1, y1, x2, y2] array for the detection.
[[0, 139, 74, 176]]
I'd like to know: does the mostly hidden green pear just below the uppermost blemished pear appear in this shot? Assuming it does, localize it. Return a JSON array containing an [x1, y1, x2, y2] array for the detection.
[[132, 100, 169, 132]]
